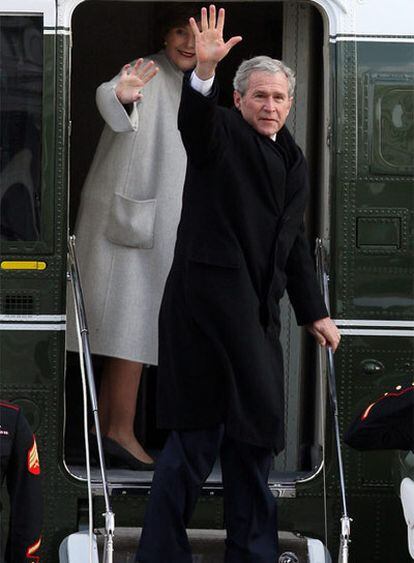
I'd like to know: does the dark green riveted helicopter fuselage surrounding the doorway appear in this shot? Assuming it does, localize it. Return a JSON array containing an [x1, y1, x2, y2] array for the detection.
[[0, 4, 414, 563]]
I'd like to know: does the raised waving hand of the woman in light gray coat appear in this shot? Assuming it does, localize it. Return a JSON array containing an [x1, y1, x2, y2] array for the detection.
[[115, 59, 159, 104]]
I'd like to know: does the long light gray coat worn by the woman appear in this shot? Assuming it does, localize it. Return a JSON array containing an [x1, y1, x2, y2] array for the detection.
[[67, 52, 186, 364]]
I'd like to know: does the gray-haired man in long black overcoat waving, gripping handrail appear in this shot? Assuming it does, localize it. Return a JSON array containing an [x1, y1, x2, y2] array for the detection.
[[137, 6, 339, 563]]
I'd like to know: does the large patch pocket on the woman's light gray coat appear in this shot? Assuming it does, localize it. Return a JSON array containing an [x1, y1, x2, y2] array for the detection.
[[105, 193, 157, 248]]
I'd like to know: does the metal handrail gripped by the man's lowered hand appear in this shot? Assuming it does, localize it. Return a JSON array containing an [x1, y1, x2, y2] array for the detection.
[[315, 238, 352, 563]]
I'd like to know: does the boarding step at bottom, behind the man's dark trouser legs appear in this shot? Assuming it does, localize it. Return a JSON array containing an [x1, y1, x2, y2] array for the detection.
[[93, 528, 331, 563]]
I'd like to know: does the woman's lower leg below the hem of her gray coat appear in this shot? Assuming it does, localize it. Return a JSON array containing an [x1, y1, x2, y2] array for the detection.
[[98, 358, 153, 463]]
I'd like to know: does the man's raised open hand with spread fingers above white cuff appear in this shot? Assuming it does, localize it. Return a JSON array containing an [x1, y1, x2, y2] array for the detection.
[[190, 5, 242, 79]]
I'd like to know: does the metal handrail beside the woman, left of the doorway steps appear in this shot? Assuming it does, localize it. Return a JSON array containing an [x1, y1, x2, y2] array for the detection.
[[68, 235, 115, 563]]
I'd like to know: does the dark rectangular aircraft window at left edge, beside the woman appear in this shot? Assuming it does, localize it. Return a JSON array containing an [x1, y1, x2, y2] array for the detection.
[[0, 16, 43, 241]]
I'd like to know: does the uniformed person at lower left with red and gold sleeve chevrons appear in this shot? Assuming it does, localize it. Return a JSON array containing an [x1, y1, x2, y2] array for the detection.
[[0, 401, 43, 563]]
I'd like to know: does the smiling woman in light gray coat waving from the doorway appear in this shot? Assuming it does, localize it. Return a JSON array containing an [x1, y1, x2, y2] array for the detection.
[[67, 5, 200, 469]]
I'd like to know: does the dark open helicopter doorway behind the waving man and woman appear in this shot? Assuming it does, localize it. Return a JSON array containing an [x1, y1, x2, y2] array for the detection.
[[65, 0, 326, 487]]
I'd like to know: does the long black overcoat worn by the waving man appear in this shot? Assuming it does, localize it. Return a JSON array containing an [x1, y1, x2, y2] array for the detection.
[[157, 76, 327, 451]]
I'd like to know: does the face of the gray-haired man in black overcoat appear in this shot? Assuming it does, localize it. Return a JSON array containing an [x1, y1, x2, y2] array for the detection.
[[233, 71, 293, 137]]
